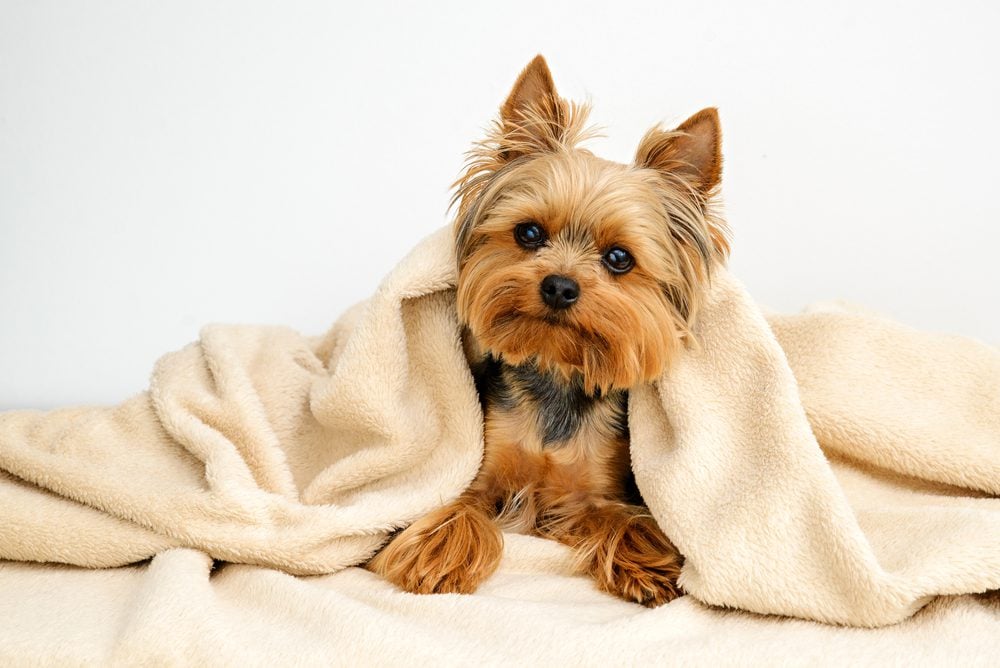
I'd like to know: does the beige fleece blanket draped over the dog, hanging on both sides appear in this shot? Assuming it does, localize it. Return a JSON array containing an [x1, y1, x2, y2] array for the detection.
[[0, 229, 1000, 626]]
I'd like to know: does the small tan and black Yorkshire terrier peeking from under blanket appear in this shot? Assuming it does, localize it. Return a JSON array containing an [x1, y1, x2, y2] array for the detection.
[[368, 56, 729, 606]]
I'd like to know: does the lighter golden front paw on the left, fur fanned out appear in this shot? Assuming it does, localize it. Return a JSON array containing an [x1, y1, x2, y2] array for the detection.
[[367, 504, 503, 594]]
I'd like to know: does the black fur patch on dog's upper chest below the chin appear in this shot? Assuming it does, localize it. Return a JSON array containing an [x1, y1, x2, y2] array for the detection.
[[473, 355, 628, 447]]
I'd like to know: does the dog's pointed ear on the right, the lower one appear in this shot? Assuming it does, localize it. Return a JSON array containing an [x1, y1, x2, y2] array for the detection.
[[635, 107, 722, 198]]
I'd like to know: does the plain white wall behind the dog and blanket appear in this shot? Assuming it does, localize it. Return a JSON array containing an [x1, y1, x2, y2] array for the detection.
[[0, 0, 1000, 409]]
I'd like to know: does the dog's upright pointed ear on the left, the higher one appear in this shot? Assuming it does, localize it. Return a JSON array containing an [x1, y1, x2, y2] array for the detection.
[[499, 55, 568, 160]]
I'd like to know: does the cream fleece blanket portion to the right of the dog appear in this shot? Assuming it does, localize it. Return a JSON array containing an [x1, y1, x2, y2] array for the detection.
[[629, 274, 1000, 626]]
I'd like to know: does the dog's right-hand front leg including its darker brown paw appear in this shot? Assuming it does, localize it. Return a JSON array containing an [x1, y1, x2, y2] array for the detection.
[[539, 501, 683, 607]]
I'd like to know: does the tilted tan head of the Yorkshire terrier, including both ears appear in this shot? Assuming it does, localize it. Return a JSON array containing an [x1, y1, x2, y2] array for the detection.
[[455, 57, 728, 393]]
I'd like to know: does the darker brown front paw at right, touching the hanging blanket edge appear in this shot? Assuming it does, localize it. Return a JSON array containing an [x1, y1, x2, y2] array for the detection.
[[591, 516, 683, 608]]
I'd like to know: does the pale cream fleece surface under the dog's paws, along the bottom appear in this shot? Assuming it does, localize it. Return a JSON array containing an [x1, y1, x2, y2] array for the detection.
[[0, 536, 1000, 668]]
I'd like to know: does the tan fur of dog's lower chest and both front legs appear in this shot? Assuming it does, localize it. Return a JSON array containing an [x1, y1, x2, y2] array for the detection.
[[368, 392, 682, 605]]
